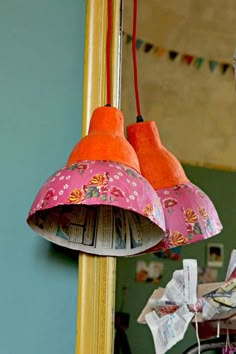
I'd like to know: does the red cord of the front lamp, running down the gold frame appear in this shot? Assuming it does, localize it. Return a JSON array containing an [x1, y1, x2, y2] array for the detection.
[[106, 0, 112, 106]]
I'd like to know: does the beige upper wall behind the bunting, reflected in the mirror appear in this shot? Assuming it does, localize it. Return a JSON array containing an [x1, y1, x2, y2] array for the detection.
[[121, 0, 236, 170]]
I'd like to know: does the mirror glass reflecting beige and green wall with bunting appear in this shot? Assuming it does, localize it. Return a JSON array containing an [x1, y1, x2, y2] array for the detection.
[[116, 0, 236, 354]]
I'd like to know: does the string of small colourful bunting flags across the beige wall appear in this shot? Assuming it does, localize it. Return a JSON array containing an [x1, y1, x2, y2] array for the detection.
[[123, 32, 234, 74]]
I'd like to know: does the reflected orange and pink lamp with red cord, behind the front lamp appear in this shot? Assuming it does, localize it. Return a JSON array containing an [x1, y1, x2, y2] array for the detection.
[[127, 0, 222, 252]]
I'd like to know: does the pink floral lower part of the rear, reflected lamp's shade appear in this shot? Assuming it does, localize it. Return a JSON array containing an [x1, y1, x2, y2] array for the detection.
[[149, 182, 222, 252]]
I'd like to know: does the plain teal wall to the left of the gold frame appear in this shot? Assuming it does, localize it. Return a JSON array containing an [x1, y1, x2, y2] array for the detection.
[[0, 0, 85, 354]]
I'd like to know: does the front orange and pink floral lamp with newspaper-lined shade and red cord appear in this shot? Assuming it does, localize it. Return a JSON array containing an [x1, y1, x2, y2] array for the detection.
[[27, 1, 165, 256]]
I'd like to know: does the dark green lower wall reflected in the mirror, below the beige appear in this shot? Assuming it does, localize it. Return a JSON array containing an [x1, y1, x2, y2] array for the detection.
[[116, 166, 236, 354]]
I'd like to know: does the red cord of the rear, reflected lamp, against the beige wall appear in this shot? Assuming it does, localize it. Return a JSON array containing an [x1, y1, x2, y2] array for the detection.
[[132, 0, 143, 122]]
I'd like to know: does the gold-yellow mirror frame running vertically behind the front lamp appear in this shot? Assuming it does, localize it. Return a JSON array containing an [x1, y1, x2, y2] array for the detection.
[[75, 0, 121, 354]]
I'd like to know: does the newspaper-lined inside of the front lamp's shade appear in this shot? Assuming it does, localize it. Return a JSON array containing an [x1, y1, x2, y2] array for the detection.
[[29, 205, 163, 256]]
